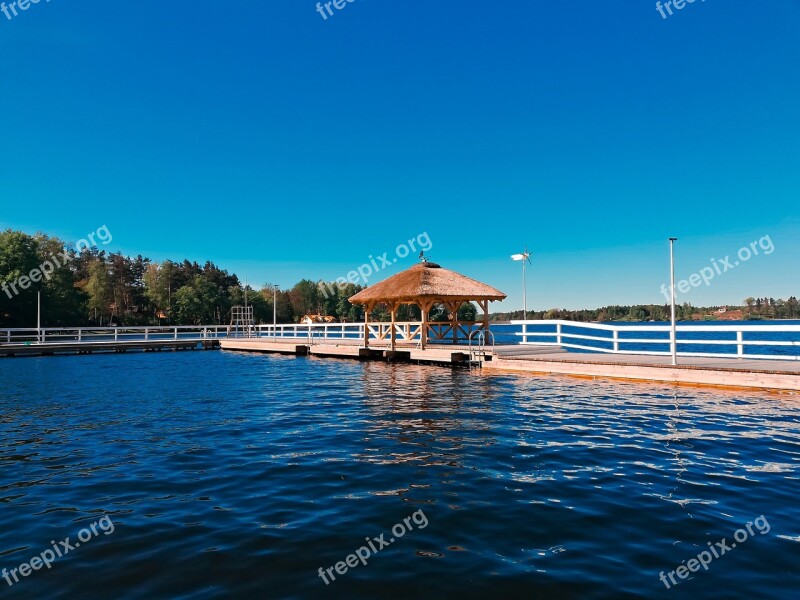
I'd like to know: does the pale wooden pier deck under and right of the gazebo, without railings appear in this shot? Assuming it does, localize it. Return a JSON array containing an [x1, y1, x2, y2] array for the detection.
[[220, 338, 800, 391]]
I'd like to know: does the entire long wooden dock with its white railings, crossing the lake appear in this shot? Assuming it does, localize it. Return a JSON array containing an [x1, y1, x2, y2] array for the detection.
[[0, 321, 800, 392]]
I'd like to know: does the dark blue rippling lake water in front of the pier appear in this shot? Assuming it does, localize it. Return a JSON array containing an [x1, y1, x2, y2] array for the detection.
[[0, 352, 800, 598]]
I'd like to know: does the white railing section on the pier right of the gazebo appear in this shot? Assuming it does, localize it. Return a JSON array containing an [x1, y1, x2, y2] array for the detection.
[[511, 320, 800, 360]]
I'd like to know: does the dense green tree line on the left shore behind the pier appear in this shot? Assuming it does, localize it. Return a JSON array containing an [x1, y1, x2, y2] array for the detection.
[[0, 229, 477, 327]]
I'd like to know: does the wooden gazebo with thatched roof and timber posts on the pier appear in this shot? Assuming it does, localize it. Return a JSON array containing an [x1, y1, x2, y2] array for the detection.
[[349, 261, 506, 351]]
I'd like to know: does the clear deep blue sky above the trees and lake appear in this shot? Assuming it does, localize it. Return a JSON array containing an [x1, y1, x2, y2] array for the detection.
[[0, 0, 800, 310]]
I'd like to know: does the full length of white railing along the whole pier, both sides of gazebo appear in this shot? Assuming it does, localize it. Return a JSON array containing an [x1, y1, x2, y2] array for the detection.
[[7, 320, 800, 360]]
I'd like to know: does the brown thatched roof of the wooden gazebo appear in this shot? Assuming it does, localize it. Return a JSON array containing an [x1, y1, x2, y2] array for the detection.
[[350, 262, 506, 304]]
